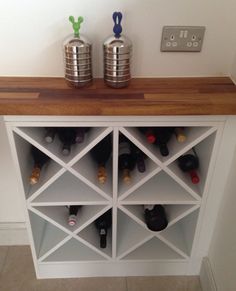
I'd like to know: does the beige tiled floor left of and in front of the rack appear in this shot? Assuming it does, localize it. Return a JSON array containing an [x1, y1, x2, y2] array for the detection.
[[0, 246, 201, 291]]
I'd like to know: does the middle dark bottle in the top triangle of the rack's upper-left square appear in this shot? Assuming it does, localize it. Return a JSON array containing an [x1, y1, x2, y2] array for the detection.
[[58, 127, 76, 156]]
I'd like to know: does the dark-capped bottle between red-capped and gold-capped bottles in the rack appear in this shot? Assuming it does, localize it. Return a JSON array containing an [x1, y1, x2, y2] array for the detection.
[[155, 127, 174, 157]]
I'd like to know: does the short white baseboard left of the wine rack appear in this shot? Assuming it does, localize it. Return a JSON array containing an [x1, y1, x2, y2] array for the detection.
[[0, 222, 29, 246]]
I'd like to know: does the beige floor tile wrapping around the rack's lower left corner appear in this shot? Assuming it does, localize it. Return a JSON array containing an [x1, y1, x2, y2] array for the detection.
[[0, 246, 127, 291]]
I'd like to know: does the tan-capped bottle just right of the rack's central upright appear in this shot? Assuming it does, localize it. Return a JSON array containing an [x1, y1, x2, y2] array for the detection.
[[118, 135, 135, 184]]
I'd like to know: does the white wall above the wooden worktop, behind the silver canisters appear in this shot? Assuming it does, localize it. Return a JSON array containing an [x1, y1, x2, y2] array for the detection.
[[0, 0, 236, 76]]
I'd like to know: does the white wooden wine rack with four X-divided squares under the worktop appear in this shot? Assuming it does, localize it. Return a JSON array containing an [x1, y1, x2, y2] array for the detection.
[[7, 117, 221, 278]]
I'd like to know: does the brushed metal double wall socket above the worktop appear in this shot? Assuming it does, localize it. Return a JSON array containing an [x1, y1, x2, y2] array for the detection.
[[161, 26, 206, 52]]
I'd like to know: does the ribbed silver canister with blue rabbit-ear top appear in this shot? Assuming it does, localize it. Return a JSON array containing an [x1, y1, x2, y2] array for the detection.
[[103, 12, 132, 88]]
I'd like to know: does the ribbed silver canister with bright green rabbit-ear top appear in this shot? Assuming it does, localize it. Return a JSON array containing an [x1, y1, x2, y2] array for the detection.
[[63, 16, 93, 88]]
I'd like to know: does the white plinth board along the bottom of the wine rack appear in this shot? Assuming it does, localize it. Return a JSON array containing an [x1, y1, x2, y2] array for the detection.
[[36, 261, 188, 279]]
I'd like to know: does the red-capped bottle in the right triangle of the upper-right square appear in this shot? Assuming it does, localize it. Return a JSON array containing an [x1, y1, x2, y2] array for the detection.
[[178, 149, 200, 184]]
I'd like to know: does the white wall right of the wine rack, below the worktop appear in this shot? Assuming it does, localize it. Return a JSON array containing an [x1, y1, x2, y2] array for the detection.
[[208, 117, 236, 291]]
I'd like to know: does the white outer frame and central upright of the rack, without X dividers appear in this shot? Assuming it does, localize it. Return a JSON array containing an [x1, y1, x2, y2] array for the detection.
[[4, 116, 225, 278]]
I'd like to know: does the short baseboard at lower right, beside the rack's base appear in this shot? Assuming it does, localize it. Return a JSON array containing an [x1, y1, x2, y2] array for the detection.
[[200, 257, 218, 291]]
